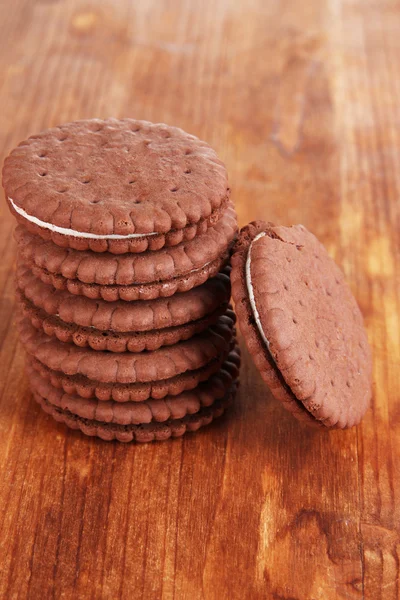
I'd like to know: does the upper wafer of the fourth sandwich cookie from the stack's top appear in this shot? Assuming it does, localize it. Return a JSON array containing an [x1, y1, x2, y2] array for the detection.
[[20, 311, 234, 383]]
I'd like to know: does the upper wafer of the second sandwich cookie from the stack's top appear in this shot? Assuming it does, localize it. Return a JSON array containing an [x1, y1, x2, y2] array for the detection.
[[15, 205, 237, 286]]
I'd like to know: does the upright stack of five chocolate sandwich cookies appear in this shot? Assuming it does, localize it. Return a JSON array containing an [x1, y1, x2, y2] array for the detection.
[[3, 119, 240, 442]]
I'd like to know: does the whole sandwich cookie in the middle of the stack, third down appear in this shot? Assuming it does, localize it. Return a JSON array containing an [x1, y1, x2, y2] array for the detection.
[[16, 265, 230, 352]]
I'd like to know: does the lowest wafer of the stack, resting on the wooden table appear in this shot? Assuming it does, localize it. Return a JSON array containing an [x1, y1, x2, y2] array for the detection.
[[33, 385, 236, 442]]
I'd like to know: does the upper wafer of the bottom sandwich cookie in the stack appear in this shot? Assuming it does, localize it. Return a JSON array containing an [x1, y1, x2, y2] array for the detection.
[[27, 354, 237, 425]]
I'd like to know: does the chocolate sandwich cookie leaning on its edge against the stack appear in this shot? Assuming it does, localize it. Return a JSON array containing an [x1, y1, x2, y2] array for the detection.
[[231, 221, 372, 428]]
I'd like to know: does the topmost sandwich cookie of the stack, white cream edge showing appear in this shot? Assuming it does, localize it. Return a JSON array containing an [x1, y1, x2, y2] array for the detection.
[[3, 119, 229, 254]]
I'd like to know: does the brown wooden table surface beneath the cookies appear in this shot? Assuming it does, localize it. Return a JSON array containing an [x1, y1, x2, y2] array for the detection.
[[0, 0, 400, 600]]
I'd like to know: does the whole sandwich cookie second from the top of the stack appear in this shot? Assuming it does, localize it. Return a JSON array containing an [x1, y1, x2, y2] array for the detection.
[[15, 205, 237, 300]]
